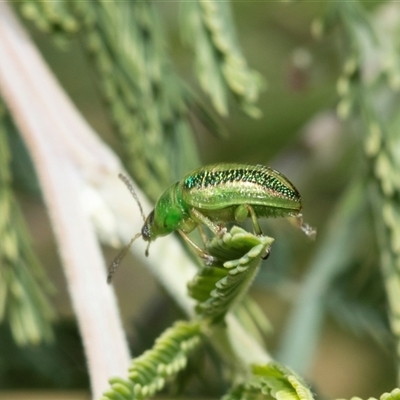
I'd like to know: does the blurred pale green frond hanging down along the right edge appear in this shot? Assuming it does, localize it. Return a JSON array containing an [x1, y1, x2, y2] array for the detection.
[[318, 2, 400, 382]]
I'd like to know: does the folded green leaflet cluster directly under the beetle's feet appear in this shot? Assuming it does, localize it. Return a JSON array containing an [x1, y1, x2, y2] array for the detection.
[[188, 226, 273, 321]]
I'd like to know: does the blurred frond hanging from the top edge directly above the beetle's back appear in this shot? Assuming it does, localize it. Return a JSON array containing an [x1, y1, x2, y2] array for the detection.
[[181, 0, 263, 117]]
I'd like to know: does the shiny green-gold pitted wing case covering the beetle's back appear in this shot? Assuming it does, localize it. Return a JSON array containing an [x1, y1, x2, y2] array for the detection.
[[181, 164, 301, 216]]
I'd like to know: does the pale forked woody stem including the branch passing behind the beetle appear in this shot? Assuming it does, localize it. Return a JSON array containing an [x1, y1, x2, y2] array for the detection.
[[0, 2, 269, 398]]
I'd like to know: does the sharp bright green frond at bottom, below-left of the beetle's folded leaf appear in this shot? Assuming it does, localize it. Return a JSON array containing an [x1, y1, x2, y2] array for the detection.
[[101, 321, 201, 400]]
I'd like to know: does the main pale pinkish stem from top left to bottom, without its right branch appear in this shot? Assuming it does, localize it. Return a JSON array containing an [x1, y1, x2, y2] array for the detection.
[[0, 3, 129, 398]]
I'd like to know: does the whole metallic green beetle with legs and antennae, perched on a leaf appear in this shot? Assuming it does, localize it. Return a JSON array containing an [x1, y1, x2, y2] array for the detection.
[[107, 164, 315, 282]]
